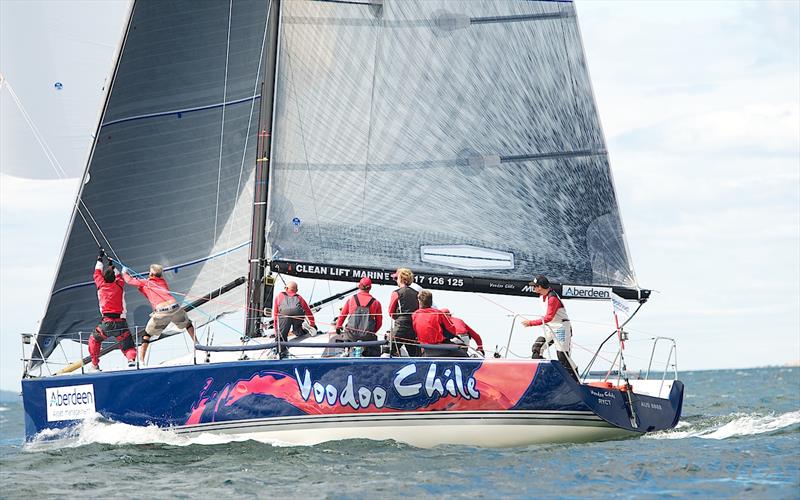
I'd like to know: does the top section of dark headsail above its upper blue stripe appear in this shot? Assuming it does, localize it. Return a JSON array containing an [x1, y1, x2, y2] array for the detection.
[[104, 0, 266, 123]]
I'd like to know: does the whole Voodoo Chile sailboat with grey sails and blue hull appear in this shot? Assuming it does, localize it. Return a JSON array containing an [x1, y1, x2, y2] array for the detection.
[[17, 0, 683, 446]]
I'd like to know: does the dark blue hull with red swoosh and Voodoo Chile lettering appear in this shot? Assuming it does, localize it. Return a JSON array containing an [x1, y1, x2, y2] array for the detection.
[[22, 358, 683, 446]]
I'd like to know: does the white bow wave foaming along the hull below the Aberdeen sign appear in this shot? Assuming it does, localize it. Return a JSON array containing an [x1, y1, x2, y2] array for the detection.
[[24, 414, 298, 451]]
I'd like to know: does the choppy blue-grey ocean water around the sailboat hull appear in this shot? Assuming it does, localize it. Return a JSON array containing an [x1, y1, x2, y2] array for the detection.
[[0, 368, 800, 498]]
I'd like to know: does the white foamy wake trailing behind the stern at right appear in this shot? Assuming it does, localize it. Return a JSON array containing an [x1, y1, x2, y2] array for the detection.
[[645, 410, 800, 439]]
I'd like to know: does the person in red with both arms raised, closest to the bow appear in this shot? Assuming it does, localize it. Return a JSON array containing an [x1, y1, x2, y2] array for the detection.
[[89, 249, 136, 371]]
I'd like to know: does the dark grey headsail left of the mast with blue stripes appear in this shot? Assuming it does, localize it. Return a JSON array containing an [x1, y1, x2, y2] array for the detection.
[[36, 0, 267, 368]]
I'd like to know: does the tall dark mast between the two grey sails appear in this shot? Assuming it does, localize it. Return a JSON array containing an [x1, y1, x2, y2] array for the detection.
[[245, 0, 281, 337]]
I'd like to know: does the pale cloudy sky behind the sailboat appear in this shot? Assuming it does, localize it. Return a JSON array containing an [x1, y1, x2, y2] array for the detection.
[[0, 0, 800, 390]]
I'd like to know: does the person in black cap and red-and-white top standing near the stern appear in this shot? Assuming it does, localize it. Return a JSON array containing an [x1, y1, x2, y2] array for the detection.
[[522, 275, 578, 381]]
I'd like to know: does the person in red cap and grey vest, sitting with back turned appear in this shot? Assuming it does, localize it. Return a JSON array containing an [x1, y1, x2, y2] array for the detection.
[[336, 277, 383, 356]]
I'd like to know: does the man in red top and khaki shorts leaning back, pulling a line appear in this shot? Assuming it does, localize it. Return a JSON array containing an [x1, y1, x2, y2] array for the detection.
[[122, 264, 197, 364]]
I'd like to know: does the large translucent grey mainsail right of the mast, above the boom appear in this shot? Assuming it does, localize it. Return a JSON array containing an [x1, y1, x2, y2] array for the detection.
[[267, 0, 638, 293]]
